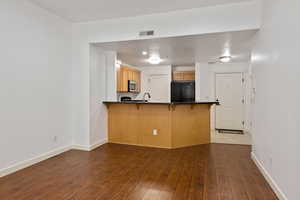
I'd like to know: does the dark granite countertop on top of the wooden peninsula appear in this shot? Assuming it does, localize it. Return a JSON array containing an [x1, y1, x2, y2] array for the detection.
[[103, 100, 220, 105]]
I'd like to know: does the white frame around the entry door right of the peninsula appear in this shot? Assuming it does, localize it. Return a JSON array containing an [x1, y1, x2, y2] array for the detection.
[[213, 72, 246, 131]]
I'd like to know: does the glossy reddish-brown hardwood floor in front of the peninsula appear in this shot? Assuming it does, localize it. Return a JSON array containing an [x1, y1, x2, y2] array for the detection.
[[0, 144, 277, 200]]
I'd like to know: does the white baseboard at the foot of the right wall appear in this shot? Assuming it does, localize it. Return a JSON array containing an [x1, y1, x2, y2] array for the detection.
[[251, 152, 288, 200]]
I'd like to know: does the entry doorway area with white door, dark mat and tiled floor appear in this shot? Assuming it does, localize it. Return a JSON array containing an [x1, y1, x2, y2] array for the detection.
[[212, 72, 252, 145]]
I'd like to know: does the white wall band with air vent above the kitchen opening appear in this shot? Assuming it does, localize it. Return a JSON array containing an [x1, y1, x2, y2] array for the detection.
[[73, 0, 261, 43]]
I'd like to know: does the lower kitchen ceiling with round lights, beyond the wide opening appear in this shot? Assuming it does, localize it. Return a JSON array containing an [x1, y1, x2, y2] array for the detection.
[[96, 30, 256, 67]]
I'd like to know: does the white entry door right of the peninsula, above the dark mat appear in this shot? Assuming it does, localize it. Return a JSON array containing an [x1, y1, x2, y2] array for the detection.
[[216, 73, 245, 130]]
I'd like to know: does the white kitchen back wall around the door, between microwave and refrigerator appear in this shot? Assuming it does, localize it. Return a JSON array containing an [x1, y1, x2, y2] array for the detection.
[[136, 65, 172, 102]]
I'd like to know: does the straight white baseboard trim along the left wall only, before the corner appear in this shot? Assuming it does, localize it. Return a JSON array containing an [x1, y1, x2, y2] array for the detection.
[[0, 145, 71, 177]]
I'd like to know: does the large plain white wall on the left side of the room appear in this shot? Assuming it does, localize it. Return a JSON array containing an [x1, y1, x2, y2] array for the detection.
[[0, 0, 72, 171]]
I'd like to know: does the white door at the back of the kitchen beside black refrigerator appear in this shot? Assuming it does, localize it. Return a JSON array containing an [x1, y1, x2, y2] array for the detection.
[[149, 74, 170, 102]]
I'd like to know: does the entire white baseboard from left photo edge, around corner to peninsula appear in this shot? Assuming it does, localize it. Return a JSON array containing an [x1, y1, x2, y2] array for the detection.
[[0, 140, 107, 177]]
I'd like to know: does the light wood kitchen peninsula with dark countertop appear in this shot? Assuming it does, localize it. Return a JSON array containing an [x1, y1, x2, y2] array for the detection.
[[103, 101, 219, 149]]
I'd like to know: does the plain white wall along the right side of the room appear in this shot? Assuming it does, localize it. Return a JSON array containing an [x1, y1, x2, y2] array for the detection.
[[252, 0, 300, 200]]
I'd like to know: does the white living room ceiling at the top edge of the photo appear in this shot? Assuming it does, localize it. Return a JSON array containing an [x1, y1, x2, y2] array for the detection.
[[31, 0, 250, 22]]
